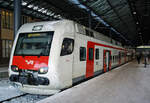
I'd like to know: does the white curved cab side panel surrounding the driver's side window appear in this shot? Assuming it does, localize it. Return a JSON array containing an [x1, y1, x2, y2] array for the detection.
[[53, 22, 75, 88]]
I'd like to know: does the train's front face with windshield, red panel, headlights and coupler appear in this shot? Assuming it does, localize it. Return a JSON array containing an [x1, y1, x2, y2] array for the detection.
[[9, 22, 58, 95]]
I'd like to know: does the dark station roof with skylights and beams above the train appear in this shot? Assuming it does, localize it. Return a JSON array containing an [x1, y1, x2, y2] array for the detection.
[[0, 0, 150, 46]]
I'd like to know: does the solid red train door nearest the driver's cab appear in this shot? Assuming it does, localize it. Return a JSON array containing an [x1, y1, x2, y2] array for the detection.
[[86, 42, 94, 78]]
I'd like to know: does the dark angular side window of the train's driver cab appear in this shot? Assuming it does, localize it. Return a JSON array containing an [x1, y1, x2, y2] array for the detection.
[[60, 38, 74, 56]]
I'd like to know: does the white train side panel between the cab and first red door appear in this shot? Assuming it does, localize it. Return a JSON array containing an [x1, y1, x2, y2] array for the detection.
[[72, 33, 87, 82]]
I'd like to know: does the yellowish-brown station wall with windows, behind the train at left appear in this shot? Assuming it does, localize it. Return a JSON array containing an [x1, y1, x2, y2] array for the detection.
[[0, 8, 40, 65]]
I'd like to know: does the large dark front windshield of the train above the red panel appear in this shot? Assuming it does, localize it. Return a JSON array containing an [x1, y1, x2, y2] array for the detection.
[[14, 32, 54, 56]]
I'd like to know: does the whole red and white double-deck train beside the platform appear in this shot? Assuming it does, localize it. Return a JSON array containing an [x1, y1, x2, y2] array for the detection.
[[9, 20, 131, 95]]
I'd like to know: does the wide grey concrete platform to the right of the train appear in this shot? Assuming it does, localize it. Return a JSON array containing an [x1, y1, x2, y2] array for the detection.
[[38, 61, 150, 103]]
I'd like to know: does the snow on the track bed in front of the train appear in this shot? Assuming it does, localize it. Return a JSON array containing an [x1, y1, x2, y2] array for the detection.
[[0, 79, 47, 103]]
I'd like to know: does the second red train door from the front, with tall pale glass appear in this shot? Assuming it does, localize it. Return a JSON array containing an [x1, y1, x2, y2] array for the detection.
[[103, 50, 111, 72]]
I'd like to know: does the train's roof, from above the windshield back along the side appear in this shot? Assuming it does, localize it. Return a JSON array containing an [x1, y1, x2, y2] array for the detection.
[[19, 19, 121, 49]]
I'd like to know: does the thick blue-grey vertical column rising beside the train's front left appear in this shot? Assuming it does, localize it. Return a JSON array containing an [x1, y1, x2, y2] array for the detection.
[[14, 0, 22, 39]]
